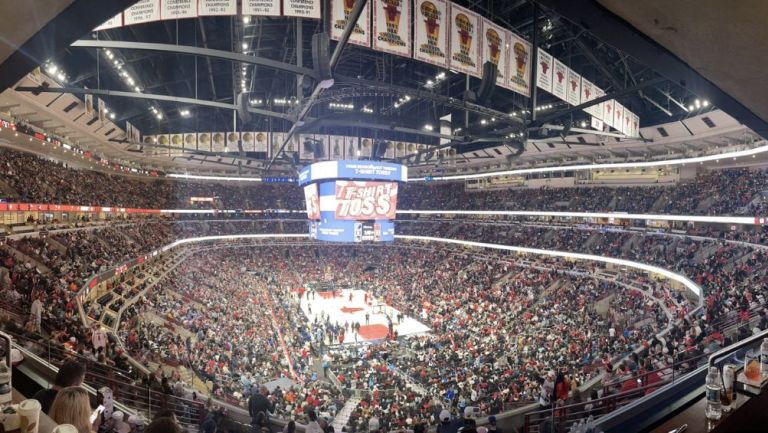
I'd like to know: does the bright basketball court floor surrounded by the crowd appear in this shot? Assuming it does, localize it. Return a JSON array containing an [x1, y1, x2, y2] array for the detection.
[[301, 289, 430, 344]]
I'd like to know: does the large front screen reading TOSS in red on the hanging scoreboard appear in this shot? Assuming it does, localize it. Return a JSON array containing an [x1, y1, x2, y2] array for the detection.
[[336, 180, 397, 220]]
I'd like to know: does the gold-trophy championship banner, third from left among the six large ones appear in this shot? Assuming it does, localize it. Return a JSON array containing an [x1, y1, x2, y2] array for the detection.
[[413, 0, 449, 68]]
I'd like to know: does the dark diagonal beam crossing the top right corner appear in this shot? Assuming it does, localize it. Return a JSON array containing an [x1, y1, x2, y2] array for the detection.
[[537, 0, 768, 137]]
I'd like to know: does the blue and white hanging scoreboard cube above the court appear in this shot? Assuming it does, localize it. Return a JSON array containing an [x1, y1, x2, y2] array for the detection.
[[299, 161, 407, 242]]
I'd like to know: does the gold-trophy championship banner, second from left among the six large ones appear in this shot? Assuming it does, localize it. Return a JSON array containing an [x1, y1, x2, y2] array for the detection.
[[373, 0, 412, 57]]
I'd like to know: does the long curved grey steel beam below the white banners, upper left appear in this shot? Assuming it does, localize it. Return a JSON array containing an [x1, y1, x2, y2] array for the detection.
[[72, 40, 317, 78]]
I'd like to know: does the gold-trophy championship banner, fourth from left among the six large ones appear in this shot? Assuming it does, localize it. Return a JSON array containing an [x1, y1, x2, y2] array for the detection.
[[449, 4, 482, 77]]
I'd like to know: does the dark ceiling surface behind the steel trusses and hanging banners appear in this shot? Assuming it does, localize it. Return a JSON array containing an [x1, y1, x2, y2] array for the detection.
[[42, 0, 696, 142]]
